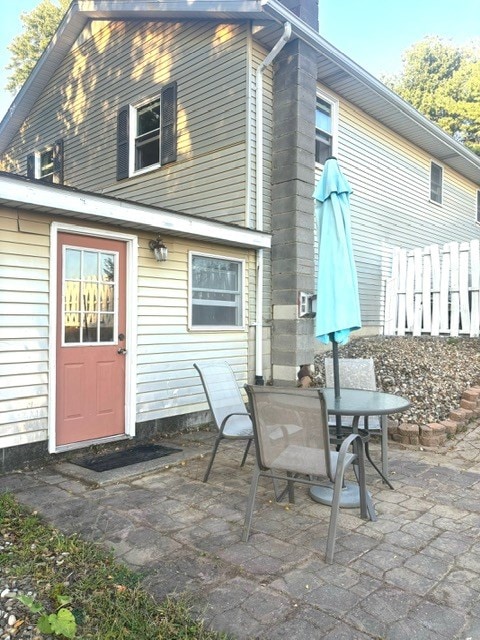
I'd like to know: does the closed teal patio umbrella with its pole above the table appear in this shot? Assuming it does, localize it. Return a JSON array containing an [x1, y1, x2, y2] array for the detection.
[[313, 158, 362, 397]]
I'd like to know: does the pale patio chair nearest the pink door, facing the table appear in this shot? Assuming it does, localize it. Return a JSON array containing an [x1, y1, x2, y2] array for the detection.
[[193, 361, 253, 482]]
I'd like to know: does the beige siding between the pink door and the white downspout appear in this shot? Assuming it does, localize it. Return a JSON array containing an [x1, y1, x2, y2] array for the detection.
[[137, 232, 255, 422]]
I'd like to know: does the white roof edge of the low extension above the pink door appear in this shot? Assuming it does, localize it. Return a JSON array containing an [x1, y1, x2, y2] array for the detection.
[[0, 171, 271, 249]]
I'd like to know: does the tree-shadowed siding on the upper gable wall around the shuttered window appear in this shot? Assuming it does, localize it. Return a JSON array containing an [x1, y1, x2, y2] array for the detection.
[[7, 21, 251, 224]]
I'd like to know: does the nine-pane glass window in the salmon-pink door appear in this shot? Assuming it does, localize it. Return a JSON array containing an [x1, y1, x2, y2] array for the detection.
[[63, 248, 117, 344]]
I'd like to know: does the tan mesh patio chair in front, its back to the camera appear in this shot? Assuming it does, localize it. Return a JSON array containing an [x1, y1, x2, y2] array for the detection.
[[242, 385, 369, 563]]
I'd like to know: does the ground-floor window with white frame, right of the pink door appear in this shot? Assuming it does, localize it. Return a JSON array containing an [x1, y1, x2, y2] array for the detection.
[[189, 253, 244, 329]]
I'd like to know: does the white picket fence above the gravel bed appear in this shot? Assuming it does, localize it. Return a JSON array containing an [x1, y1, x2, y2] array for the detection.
[[384, 240, 480, 337]]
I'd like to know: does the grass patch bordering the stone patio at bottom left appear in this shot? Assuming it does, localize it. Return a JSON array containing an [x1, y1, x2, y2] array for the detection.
[[0, 493, 227, 640]]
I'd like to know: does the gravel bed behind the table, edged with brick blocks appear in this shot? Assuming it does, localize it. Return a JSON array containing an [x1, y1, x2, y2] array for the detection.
[[315, 336, 480, 424]]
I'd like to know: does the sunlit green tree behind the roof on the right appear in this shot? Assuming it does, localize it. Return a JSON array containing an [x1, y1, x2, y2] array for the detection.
[[386, 37, 480, 155]]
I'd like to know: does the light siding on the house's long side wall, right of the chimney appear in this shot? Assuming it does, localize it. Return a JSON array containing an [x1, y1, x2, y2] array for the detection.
[[320, 90, 478, 327]]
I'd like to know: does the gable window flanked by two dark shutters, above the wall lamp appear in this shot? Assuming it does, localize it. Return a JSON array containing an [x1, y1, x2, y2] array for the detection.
[[117, 83, 177, 180]]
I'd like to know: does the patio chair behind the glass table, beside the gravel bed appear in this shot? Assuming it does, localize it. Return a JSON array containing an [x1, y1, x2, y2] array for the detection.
[[325, 358, 393, 489]]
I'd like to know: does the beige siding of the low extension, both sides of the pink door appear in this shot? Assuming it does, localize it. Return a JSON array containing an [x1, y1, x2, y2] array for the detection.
[[0, 209, 255, 449]]
